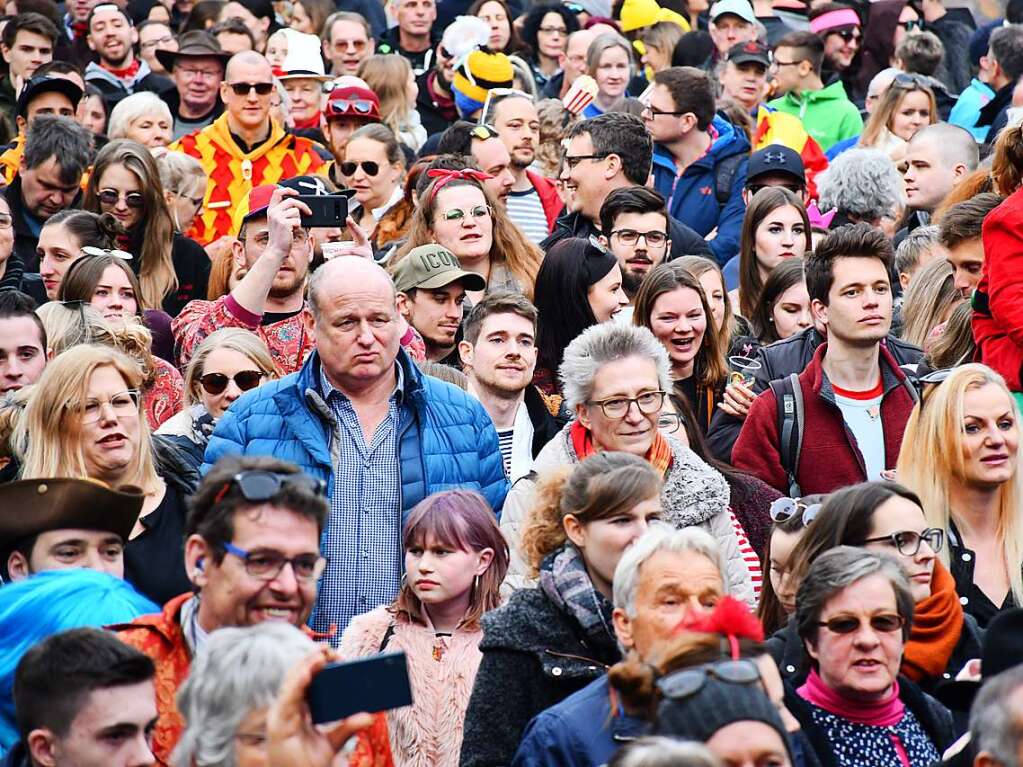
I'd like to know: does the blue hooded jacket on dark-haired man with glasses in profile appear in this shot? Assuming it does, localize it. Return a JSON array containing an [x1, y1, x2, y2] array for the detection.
[[654, 116, 750, 265]]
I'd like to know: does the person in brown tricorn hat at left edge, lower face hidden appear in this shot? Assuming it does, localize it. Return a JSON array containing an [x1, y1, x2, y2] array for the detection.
[[0, 479, 145, 581]]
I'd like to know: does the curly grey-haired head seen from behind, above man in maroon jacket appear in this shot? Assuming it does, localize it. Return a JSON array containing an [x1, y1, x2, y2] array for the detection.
[[816, 148, 905, 229]]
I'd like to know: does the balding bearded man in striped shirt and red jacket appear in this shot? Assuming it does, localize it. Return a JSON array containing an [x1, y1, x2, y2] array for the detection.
[[484, 91, 563, 243]]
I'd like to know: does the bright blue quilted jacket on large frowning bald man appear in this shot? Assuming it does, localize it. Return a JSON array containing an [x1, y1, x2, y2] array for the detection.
[[203, 351, 508, 525]]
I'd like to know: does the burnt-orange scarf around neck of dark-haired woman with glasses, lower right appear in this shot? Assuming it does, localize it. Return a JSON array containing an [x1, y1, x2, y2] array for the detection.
[[902, 561, 963, 682]]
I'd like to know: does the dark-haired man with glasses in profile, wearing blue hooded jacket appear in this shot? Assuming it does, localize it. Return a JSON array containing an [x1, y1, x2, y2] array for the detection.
[[643, 66, 750, 265]]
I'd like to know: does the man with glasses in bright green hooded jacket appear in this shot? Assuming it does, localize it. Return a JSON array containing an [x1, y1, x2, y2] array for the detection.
[[767, 32, 863, 151]]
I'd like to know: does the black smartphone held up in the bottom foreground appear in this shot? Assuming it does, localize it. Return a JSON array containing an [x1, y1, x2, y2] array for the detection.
[[306, 652, 412, 724]]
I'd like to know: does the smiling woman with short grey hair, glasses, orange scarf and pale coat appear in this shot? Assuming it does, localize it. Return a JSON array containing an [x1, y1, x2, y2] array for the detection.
[[501, 322, 754, 603]]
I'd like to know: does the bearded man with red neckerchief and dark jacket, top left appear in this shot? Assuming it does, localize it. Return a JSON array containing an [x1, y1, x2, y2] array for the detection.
[[85, 3, 171, 114]]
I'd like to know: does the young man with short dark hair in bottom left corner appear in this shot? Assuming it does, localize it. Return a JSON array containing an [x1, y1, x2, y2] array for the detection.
[[11, 629, 158, 767]]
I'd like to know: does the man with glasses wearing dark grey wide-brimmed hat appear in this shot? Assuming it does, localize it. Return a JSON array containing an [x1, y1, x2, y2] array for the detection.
[[153, 31, 230, 141]]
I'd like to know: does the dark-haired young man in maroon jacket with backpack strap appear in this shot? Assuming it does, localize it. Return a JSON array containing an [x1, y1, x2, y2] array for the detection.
[[731, 224, 916, 494]]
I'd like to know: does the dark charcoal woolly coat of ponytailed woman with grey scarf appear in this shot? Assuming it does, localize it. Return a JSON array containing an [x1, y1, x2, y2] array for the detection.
[[459, 588, 621, 767]]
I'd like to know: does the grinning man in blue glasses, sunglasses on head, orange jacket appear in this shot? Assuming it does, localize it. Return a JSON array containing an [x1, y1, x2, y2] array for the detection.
[[110, 456, 327, 764]]
